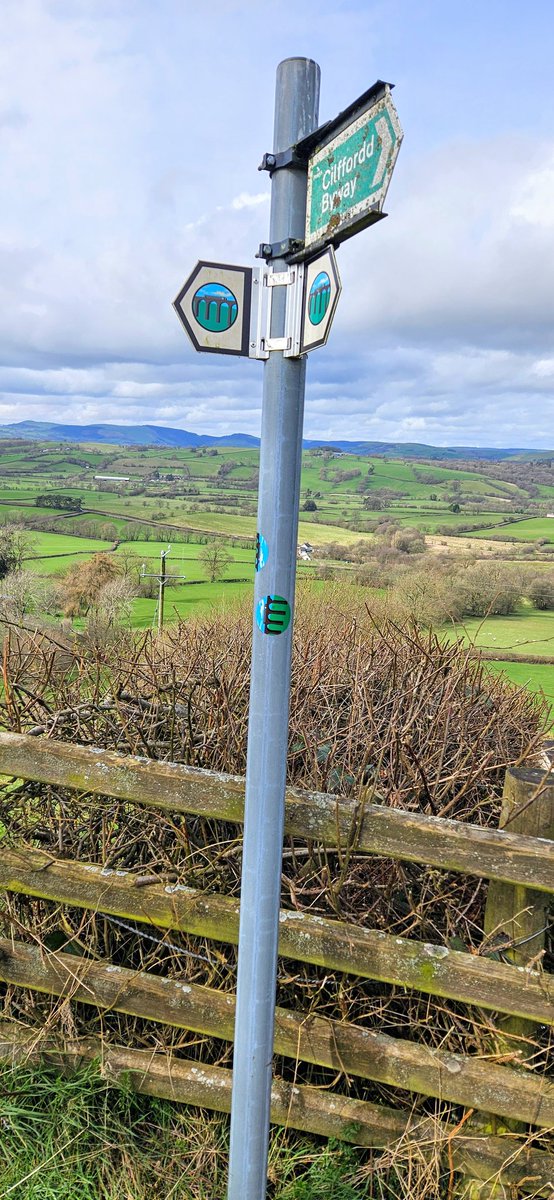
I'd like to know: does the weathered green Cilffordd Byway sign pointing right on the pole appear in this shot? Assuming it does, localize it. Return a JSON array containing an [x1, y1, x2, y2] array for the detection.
[[305, 85, 403, 255]]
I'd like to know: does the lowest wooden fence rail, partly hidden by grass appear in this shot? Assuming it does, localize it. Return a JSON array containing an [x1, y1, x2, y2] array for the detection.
[[0, 1021, 552, 1195]]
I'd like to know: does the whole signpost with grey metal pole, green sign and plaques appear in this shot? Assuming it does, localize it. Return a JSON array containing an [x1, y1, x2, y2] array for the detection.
[[174, 58, 402, 1200]]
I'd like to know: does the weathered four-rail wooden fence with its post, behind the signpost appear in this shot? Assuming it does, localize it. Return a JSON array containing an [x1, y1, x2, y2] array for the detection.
[[0, 733, 554, 1198]]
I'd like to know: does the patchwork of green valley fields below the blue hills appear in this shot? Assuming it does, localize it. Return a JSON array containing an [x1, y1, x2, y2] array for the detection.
[[0, 443, 554, 720]]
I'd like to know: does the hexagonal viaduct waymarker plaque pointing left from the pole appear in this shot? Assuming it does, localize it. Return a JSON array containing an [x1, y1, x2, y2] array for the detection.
[[173, 262, 252, 356]]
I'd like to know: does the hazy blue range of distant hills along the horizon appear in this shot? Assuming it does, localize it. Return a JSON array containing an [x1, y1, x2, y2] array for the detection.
[[0, 421, 554, 462]]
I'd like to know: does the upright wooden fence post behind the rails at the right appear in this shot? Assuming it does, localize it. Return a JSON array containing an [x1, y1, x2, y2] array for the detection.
[[456, 763, 554, 1200]]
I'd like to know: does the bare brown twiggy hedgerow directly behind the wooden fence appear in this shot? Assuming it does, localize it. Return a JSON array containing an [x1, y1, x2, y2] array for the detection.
[[0, 595, 550, 1147]]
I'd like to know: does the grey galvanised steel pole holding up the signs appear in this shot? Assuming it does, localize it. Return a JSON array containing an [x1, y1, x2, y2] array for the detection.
[[228, 58, 320, 1200]]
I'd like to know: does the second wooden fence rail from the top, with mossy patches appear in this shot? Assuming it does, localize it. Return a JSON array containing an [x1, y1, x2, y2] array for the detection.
[[0, 847, 554, 1024]]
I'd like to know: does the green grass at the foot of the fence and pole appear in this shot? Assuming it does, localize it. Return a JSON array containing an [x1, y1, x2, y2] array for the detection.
[[0, 1064, 376, 1200]]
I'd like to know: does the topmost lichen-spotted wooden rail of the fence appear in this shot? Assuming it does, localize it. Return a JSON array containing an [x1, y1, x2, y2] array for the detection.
[[0, 733, 554, 894]]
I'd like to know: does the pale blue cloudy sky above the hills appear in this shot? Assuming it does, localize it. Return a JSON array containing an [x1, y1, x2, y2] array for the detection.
[[0, 0, 554, 448]]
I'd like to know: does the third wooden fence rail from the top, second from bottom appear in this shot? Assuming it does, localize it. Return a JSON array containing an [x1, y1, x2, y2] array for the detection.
[[0, 938, 554, 1127]]
